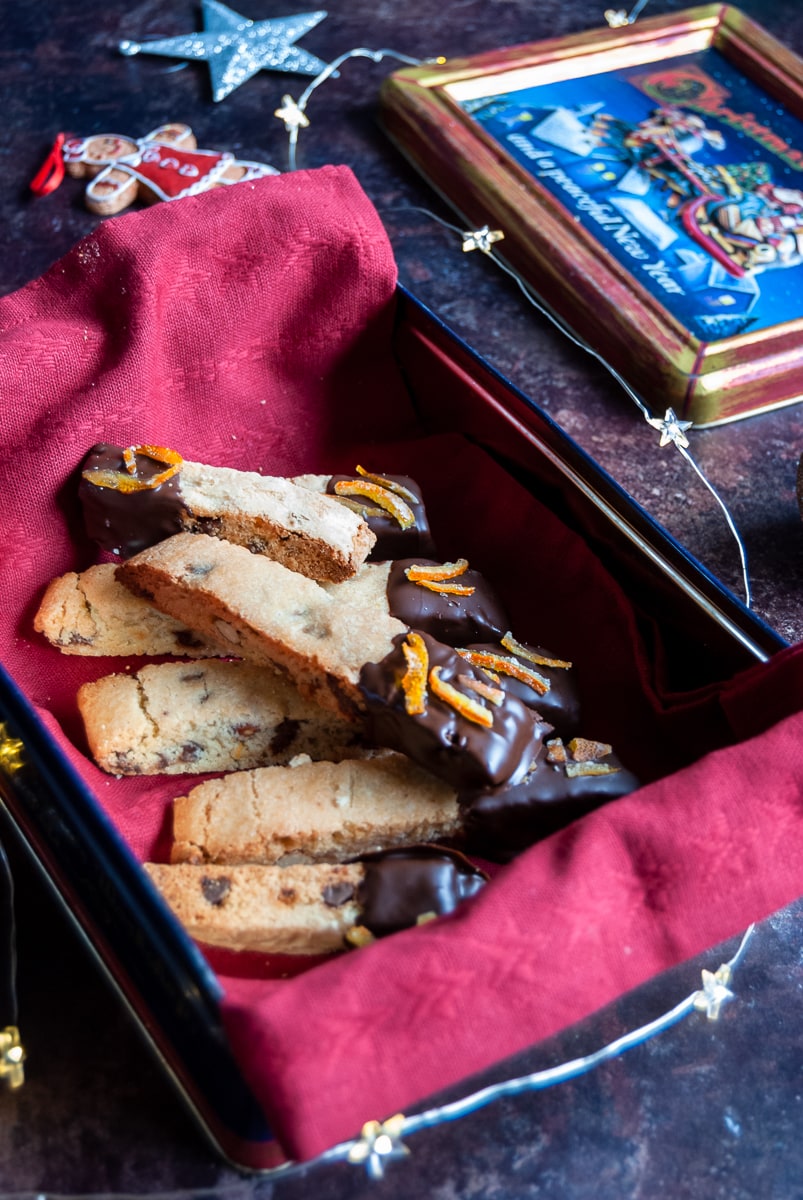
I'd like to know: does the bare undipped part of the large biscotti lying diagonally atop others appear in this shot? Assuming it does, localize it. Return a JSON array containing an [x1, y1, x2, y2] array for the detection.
[[118, 534, 407, 716]]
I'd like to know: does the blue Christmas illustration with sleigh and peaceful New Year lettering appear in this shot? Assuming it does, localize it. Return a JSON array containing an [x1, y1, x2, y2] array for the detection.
[[462, 49, 803, 342]]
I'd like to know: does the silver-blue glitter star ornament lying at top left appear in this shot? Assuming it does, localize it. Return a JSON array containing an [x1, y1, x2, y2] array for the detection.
[[119, 0, 326, 100]]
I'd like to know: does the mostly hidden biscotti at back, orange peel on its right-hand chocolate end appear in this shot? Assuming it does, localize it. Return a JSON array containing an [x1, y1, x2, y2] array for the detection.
[[292, 467, 437, 563]]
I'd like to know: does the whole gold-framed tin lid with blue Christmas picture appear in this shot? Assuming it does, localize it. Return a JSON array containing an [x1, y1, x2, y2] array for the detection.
[[380, 5, 803, 425]]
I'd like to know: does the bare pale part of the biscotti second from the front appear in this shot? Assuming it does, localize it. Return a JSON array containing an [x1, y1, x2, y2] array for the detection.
[[170, 754, 461, 864]]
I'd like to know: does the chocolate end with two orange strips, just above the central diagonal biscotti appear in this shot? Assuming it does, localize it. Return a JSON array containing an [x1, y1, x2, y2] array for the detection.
[[388, 558, 510, 646]]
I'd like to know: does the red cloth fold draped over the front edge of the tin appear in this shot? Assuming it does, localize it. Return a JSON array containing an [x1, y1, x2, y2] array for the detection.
[[217, 700, 803, 1158]]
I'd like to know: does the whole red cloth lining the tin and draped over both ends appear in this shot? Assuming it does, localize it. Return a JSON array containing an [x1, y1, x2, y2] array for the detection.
[[0, 168, 803, 1157]]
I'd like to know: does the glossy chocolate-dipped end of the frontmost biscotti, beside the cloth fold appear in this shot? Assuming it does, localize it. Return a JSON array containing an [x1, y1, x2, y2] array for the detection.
[[356, 846, 487, 937]]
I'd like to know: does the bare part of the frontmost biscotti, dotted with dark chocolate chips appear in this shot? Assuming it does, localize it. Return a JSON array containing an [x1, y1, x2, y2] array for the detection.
[[145, 863, 365, 954]]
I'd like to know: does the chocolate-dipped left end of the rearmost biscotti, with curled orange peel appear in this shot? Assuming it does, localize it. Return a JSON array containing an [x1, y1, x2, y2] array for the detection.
[[78, 442, 184, 558]]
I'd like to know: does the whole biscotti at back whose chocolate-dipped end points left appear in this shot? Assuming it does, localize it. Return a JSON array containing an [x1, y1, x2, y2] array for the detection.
[[79, 443, 376, 582]]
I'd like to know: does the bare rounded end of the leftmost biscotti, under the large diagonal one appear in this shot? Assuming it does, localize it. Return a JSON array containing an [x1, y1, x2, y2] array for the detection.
[[34, 563, 218, 658]]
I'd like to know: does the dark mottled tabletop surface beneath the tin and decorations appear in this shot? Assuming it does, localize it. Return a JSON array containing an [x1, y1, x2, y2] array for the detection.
[[0, 0, 803, 1200]]
